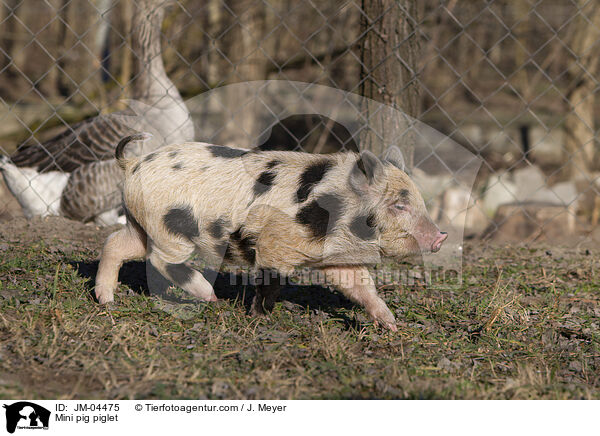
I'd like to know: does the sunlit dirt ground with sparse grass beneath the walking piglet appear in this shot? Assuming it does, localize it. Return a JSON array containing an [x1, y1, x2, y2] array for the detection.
[[0, 218, 600, 399]]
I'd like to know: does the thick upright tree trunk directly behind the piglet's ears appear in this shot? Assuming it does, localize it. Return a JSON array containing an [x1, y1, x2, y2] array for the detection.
[[361, 0, 420, 168]]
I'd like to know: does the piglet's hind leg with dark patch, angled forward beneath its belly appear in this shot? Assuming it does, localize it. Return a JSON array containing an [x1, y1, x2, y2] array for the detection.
[[148, 246, 217, 301]]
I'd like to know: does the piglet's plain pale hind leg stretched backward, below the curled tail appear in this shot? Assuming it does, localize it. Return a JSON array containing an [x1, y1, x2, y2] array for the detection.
[[95, 222, 146, 304]]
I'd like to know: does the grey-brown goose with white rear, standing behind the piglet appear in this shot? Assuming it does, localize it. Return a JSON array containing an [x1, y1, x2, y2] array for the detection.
[[0, 0, 194, 225]]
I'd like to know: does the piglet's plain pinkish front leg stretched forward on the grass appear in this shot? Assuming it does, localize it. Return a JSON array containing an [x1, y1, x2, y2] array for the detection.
[[323, 266, 398, 332]]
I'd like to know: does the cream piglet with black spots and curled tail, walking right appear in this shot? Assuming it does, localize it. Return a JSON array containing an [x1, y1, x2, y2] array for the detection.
[[95, 134, 447, 331]]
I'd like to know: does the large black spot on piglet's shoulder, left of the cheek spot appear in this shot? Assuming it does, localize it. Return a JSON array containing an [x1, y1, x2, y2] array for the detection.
[[296, 194, 343, 239]]
